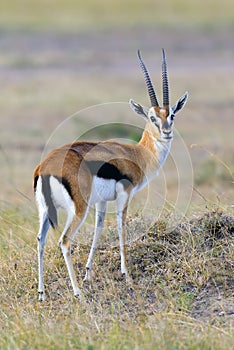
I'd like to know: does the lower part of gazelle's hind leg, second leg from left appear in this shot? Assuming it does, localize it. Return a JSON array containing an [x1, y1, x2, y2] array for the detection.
[[59, 208, 88, 300]]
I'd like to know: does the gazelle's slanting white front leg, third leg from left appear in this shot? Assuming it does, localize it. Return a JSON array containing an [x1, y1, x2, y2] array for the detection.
[[84, 202, 107, 281]]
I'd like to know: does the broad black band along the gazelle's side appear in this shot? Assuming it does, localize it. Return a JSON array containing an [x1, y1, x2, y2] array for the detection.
[[85, 160, 132, 187]]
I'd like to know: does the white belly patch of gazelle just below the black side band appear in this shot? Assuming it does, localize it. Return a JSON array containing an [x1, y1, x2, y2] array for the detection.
[[90, 176, 116, 205]]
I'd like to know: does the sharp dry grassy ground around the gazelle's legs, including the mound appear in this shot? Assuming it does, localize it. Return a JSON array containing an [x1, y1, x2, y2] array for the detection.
[[0, 207, 234, 350]]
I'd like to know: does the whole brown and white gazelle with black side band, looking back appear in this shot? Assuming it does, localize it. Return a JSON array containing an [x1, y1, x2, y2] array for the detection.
[[34, 50, 188, 300]]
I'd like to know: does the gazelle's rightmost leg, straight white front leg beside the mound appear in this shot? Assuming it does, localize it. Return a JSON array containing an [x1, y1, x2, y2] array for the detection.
[[116, 183, 130, 280]]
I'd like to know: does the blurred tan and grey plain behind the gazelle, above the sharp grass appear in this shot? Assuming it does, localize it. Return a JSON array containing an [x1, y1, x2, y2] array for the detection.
[[0, 0, 234, 216]]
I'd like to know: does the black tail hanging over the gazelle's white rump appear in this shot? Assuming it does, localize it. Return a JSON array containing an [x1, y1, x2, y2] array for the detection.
[[42, 175, 58, 228]]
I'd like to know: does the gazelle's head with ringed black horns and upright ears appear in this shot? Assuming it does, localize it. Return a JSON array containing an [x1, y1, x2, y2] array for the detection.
[[129, 49, 188, 141]]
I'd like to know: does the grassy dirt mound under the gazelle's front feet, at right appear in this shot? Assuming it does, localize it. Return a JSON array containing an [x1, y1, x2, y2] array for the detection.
[[79, 211, 234, 323]]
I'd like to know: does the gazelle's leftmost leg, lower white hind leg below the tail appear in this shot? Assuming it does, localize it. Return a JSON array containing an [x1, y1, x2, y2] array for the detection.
[[37, 214, 50, 301]]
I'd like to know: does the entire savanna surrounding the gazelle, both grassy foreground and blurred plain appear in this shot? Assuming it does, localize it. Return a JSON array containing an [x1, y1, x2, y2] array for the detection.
[[0, 0, 234, 350]]
